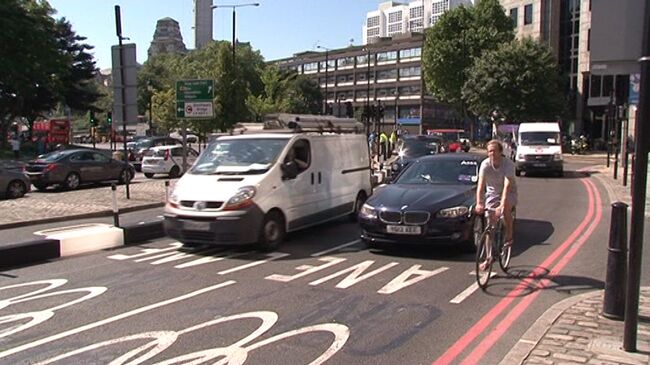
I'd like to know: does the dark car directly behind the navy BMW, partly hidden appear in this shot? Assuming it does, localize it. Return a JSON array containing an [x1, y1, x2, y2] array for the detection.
[[386, 135, 447, 177]]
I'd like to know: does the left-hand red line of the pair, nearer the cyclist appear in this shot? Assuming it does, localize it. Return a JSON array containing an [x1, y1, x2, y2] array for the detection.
[[433, 179, 596, 365]]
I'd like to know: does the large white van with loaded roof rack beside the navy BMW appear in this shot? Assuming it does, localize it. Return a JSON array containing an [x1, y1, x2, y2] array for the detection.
[[164, 114, 371, 250]]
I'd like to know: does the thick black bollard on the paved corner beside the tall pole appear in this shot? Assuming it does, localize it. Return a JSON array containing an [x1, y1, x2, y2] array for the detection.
[[603, 202, 628, 320]]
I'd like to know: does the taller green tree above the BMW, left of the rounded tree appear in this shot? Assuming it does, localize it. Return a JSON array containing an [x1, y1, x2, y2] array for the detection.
[[422, 0, 514, 114]]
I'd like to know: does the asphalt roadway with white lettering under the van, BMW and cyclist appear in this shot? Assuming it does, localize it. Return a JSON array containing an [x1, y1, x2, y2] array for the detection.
[[0, 160, 650, 365]]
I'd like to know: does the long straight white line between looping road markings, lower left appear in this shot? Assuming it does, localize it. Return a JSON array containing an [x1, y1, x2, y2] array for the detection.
[[0, 280, 236, 359]]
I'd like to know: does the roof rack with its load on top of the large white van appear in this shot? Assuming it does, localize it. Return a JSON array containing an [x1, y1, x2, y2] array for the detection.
[[264, 113, 364, 133]]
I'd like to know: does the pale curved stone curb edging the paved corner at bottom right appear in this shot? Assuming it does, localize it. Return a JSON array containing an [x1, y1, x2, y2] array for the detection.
[[499, 289, 604, 365]]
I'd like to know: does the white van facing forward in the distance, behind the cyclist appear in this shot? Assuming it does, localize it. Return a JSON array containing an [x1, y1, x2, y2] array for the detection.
[[515, 123, 564, 176]]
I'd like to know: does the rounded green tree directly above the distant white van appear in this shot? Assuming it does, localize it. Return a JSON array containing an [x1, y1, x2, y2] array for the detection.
[[463, 39, 566, 121]]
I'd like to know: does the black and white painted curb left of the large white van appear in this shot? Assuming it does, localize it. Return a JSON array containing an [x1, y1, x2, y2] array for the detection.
[[0, 220, 165, 270]]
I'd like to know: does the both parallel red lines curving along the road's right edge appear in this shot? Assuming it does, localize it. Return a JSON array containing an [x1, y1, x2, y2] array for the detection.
[[433, 178, 602, 365]]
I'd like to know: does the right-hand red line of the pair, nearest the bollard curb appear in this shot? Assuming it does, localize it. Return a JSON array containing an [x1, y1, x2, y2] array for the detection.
[[461, 180, 603, 365]]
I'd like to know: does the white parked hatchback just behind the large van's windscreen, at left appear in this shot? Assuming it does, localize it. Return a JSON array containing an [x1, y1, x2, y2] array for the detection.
[[142, 145, 199, 178]]
